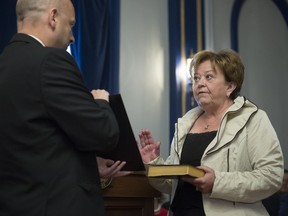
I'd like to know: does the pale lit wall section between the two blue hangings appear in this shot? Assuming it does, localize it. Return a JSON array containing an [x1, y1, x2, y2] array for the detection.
[[120, 0, 170, 157]]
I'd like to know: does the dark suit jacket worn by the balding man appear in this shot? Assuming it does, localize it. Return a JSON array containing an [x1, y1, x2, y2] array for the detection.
[[0, 34, 119, 216]]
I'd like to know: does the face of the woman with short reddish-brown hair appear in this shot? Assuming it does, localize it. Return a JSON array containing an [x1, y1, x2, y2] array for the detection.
[[192, 60, 235, 109]]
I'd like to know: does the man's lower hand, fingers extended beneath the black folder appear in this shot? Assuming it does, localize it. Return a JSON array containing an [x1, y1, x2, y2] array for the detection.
[[96, 157, 133, 178]]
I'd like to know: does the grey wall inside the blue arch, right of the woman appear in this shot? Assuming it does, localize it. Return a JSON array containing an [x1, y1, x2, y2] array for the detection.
[[239, 0, 288, 168]]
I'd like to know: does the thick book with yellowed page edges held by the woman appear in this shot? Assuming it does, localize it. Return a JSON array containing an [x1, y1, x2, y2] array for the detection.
[[147, 165, 205, 178]]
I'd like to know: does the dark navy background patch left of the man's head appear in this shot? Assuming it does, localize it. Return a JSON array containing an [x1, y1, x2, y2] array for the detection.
[[0, 0, 17, 53]]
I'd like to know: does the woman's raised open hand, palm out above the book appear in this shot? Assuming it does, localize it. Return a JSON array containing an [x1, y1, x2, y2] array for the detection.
[[137, 129, 160, 163]]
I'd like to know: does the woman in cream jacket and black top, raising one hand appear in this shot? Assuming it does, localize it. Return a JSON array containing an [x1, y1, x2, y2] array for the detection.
[[139, 50, 283, 216]]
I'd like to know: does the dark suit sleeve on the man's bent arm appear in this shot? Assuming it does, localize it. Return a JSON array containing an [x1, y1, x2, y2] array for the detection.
[[41, 50, 119, 153]]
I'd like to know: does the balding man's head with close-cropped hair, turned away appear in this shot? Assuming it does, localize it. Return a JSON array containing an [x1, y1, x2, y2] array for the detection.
[[16, 0, 75, 49]]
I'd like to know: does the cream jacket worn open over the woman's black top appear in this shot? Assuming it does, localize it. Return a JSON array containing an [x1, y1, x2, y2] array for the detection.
[[150, 96, 283, 216]]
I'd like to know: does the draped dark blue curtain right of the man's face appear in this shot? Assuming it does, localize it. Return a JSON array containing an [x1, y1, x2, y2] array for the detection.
[[71, 0, 120, 94]]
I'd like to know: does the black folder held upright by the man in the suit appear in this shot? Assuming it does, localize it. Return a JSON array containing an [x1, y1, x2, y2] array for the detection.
[[104, 94, 145, 171]]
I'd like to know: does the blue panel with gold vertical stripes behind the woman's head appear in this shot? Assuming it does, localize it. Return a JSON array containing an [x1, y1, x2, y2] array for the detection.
[[168, 0, 205, 139]]
